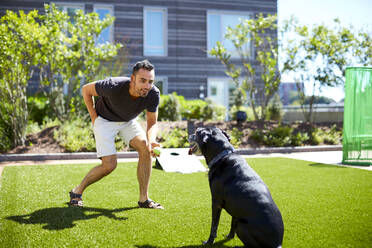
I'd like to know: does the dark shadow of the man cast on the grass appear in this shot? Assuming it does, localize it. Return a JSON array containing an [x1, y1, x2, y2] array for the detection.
[[6, 204, 138, 230]]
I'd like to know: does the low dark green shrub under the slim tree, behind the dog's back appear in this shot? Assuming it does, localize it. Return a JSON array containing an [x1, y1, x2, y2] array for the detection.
[[250, 125, 309, 147]]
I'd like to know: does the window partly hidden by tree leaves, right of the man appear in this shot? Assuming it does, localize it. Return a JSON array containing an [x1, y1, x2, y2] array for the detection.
[[207, 11, 249, 57]]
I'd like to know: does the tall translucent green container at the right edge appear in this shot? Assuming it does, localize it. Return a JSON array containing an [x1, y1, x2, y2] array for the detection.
[[342, 67, 372, 165]]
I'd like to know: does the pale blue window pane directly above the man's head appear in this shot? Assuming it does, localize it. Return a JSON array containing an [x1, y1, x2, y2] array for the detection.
[[143, 7, 168, 56]]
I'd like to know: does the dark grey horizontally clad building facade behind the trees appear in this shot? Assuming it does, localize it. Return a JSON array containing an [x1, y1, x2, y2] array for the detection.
[[0, 0, 277, 106]]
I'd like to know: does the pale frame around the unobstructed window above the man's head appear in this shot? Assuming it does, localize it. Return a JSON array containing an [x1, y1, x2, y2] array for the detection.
[[143, 6, 168, 57]]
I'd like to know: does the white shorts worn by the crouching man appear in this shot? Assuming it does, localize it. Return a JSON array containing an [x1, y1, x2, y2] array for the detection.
[[93, 116, 146, 158]]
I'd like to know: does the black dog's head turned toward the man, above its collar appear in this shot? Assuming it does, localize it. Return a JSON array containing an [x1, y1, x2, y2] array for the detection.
[[189, 127, 234, 163]]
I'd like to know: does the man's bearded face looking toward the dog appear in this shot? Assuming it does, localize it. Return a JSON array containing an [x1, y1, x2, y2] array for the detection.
[[132, 69, 155, 97]]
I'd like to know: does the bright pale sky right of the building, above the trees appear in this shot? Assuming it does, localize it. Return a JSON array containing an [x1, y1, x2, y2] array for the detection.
[[278, 0, 372, 101]]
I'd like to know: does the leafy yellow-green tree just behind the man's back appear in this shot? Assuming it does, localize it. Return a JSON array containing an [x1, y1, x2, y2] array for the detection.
[[40, 5, 122, 121]]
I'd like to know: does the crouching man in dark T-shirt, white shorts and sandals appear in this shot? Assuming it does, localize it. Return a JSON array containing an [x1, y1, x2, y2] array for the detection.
[[70, 60, 163, 209]]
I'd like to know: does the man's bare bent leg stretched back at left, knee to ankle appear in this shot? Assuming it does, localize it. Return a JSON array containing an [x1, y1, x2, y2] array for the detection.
[[72, 154, 117, 194]]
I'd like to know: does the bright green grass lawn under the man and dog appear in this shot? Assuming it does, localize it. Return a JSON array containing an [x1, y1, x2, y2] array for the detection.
[[0, 158, 372, 248]]
